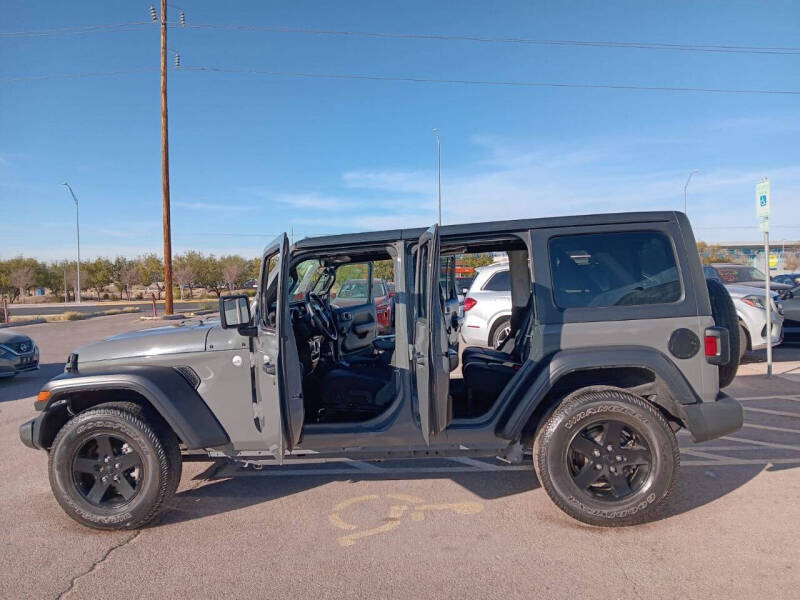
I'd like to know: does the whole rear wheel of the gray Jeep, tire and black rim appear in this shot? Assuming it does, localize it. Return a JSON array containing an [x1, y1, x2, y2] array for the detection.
[[533, 389, 680, 527]]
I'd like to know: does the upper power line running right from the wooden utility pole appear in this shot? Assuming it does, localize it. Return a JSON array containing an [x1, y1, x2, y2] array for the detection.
[[186, 23, 800, 55]]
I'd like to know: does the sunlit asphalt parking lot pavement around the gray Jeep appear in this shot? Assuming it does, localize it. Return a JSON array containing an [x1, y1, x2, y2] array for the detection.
[[0, 315, 800, 599]]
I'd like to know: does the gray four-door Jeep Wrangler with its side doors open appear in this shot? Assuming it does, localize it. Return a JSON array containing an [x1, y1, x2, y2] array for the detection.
[[20, 212, 742, 529]]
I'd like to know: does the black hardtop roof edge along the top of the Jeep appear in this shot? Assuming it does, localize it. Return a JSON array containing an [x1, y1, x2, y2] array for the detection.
[[295, 211, 686, 248]]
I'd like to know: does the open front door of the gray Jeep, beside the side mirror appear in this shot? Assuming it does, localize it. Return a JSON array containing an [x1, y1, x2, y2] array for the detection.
[[251, 233, 305, 462]]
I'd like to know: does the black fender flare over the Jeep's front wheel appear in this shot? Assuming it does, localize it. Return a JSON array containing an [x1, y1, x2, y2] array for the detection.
[[35, 366, 230, 450]]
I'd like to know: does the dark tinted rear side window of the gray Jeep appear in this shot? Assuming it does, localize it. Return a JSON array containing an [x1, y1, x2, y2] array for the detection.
[[549, 231, 683, 308]]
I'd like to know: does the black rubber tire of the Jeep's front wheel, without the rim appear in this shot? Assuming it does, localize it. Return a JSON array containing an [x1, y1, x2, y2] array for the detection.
[[48, 402, 181, 530]]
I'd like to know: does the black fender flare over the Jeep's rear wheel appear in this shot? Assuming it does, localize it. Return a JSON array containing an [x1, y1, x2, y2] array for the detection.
[[497, 346, 700, 440]]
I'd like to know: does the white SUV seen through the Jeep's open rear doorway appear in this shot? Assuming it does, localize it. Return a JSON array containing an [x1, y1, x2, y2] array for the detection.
[[461, 262, 511, 348]]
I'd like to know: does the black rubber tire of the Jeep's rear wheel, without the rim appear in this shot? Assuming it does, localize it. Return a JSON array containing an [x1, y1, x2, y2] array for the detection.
[[533, 387, 680, 527]]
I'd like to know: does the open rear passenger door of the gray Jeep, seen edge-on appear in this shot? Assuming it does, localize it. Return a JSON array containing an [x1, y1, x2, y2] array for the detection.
[[413, 225, 452, 444]]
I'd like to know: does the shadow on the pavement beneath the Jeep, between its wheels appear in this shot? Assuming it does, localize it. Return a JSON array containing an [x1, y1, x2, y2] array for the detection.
[[159, 465, 540, 526]]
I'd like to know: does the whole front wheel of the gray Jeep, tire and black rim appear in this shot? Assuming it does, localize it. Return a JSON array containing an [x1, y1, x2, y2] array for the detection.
[[48, 405, 180, 529]]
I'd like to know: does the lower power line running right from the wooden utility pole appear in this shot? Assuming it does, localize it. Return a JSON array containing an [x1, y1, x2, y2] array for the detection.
[[181, 66, 800, 96]]
